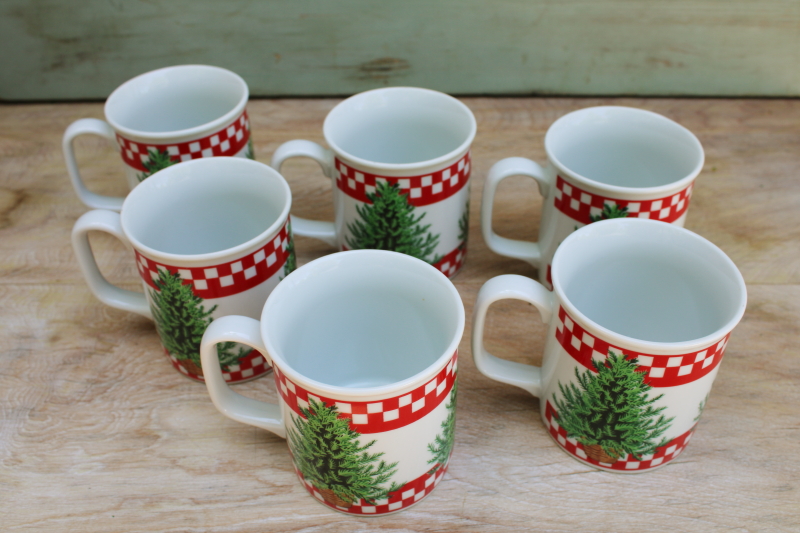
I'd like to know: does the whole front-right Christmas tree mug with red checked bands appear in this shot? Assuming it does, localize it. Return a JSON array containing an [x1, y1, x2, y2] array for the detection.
[[472, 219, 747, 472]]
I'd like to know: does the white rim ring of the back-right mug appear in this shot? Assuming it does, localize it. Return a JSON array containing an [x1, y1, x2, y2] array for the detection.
[[544, 105, 705, 197]]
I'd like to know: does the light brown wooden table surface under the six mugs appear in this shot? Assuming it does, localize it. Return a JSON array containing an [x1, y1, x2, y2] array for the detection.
[[0, 98, 800, 533]]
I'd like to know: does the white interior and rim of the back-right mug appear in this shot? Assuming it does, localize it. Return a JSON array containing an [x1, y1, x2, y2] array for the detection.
[[545, 106, 704, 188]]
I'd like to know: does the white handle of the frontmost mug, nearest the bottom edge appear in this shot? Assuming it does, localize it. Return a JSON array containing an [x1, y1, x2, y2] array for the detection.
[[200, 316, 284, 439]]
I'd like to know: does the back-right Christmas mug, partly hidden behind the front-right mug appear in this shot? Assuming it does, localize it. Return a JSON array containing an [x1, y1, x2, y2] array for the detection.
[[481, 106, 704, 289]]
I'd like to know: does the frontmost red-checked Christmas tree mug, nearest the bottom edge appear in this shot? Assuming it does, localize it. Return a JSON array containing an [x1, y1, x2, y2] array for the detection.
[[200, 250, 464, 516]]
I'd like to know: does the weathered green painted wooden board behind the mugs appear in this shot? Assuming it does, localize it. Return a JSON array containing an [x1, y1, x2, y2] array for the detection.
[[0, 0, 800, 100]]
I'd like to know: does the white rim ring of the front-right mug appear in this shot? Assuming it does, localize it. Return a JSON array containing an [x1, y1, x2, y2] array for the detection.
[[552, 218, 747, 353]]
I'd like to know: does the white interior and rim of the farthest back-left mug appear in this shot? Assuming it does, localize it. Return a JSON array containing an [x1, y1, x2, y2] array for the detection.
[[105, 65, 248, 137]]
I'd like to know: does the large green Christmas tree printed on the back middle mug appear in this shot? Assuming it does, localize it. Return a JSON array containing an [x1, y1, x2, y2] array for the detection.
[[346, 181, 441, 264]]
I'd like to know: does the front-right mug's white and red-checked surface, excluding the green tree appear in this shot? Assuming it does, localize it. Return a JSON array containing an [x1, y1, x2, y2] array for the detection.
[[472, 219, 747, 472]]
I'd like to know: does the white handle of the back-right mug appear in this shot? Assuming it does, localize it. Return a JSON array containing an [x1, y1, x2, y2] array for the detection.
[[481, 157, 551, 268]]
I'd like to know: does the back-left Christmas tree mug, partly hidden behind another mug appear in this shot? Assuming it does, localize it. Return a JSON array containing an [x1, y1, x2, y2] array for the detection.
[[62, 65, 255, 211]]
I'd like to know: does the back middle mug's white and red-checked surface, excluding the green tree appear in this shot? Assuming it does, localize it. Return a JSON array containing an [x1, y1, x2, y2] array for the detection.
[[272, 87, 477, 276]]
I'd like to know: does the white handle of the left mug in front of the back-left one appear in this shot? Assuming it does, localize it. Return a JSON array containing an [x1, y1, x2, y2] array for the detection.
[[72, 209, 153, 319]]
